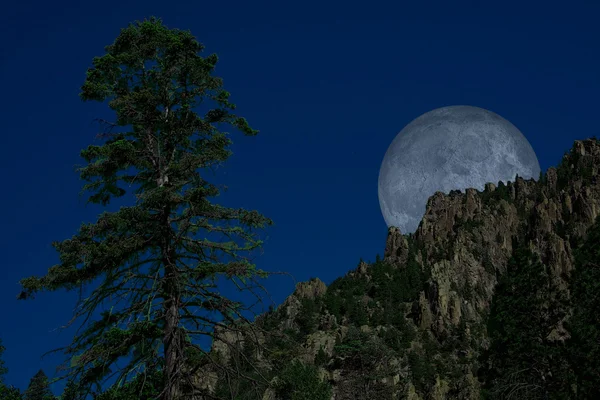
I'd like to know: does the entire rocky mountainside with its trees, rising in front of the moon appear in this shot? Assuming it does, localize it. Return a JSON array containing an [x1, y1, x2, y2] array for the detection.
[[198, 138, 600, 400]]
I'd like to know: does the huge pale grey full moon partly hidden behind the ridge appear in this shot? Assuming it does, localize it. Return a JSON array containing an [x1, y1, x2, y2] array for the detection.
[[378, 106, 540, 233]]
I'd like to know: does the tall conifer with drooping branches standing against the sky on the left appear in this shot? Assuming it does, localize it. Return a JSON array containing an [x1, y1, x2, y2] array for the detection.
[[19, 17, 272, 400]]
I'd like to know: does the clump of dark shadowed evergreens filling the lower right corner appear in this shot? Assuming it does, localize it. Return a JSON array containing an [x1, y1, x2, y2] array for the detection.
[[480, 218, 600, 400]]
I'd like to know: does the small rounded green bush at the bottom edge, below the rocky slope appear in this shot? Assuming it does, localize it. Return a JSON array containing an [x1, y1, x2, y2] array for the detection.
[[275, 360, 332, 400]]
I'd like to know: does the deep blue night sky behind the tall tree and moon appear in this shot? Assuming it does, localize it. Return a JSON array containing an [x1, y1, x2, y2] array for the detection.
[[0, 0, 600, 394]]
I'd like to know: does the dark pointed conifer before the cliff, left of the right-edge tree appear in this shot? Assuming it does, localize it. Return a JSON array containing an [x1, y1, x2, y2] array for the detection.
[[479, 240, 570, 399]]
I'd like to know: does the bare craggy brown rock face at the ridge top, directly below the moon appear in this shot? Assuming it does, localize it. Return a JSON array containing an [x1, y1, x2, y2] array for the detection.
[[412, 140, 600, 335]]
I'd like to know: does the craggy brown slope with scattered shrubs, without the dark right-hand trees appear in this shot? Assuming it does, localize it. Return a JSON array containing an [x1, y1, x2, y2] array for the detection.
[[202, 139, 600, 400]]
